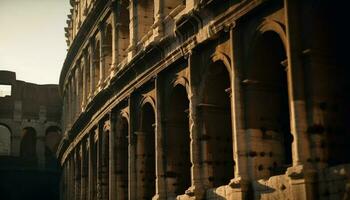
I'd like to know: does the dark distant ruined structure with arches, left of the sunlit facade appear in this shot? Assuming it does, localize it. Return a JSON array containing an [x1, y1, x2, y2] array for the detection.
[[0, 71, 62, 200]]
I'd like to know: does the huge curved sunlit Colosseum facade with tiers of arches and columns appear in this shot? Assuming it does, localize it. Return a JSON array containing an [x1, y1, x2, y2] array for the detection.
[[57, 0, 350, 200]]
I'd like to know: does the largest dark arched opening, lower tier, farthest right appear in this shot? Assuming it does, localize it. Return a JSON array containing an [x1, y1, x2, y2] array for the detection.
[[243, 31, 292, 178]]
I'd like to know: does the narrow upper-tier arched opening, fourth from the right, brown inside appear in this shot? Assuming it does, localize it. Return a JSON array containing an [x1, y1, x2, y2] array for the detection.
[[103, 24, 113, 80]]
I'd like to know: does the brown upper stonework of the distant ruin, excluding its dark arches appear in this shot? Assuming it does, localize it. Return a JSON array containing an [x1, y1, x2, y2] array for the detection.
[[0, 71, 62, 168]]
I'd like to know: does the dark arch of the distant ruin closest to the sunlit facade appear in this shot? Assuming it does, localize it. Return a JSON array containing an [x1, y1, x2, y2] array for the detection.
[[45, 126, 61, 169]]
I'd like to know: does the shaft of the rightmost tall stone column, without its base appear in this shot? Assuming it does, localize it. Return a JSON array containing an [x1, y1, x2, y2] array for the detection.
[[284, 0, 310, 169]]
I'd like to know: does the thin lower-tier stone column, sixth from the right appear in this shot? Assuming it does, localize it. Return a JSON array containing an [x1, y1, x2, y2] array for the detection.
[[108, 111, 117, 200]]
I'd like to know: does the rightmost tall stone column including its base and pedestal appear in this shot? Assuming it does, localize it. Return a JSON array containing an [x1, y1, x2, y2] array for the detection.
[[284, 0, 316, 199]]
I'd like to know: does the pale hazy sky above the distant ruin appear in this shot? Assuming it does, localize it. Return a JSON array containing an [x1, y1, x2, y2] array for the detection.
[[0, 0, 70, 84]]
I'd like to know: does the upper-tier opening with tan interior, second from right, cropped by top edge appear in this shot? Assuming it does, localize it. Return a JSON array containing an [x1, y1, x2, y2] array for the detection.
[[137, 0, 154, 41]]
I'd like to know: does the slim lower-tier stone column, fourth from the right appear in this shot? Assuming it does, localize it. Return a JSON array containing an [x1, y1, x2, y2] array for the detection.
[[154, 76, 166, 199]]
